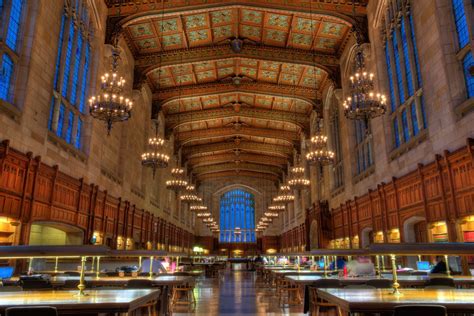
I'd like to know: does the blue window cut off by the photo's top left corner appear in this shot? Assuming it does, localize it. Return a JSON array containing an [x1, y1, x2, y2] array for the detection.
[[0, 0, 26, 103]]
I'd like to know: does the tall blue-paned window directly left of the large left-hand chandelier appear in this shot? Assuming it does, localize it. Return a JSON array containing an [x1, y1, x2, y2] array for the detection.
[[48, 0, 92, 149]]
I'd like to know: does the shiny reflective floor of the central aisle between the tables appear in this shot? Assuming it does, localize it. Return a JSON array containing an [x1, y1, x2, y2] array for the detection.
[[173, 269, 303, 316]]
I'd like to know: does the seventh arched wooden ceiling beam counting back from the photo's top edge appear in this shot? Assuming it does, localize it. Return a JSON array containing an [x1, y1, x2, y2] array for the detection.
[[187, 153, 288, 167]]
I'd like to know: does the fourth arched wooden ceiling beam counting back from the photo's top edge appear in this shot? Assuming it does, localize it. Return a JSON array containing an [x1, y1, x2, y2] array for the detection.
[[166, 107, 309, 130]]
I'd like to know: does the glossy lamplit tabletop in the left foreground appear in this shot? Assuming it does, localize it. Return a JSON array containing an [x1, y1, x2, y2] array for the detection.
[[0, 289, 160, 309]]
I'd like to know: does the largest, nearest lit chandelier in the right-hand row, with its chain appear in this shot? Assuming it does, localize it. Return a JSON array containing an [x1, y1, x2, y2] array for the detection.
[[343, 2, 386, 131]]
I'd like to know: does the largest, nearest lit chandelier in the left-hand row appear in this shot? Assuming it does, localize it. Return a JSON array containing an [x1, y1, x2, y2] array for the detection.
[[89, 39, 133, 135]]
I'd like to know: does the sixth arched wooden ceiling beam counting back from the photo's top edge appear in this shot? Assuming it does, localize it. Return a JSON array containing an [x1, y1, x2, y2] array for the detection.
[[182, 141, 293, 158]]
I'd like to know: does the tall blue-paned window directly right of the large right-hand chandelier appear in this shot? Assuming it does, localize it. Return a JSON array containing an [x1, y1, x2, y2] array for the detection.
[[383, 0, 427, 148]]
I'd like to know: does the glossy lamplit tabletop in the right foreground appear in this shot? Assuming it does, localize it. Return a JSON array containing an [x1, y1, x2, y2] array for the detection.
[[318, 289, 474, 312]]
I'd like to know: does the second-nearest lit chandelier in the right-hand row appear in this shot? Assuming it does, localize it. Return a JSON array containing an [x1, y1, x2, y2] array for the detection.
[[306, 118, 335, 165]]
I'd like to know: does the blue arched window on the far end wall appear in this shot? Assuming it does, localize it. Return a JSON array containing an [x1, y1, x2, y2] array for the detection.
[[219, 189, 256, 243]]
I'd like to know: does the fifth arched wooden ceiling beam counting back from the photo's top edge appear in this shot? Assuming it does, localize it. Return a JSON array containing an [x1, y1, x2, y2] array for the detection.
[[175, 126, 299, 145]]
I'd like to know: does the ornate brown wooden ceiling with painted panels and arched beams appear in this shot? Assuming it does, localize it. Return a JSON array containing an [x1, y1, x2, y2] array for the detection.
[[106, 0, 367, 182]]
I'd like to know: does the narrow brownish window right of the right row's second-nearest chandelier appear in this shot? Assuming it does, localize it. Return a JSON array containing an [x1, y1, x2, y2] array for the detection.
[[329, 104, 344, 190]]
